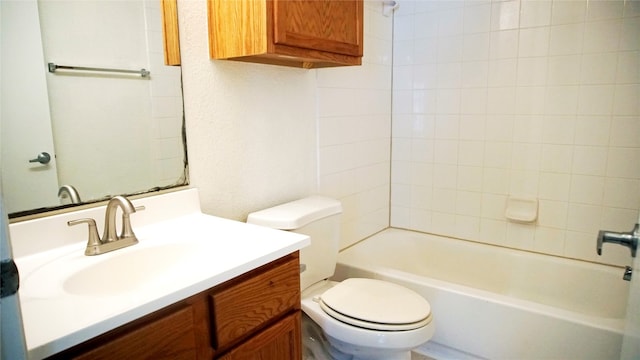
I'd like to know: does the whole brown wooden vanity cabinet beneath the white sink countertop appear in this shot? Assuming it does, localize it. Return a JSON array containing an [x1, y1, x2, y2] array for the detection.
[[51, 252, 302, 360]]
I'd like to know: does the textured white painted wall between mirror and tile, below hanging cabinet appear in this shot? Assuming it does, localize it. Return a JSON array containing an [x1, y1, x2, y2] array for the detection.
[[178, 0, 317, 220]]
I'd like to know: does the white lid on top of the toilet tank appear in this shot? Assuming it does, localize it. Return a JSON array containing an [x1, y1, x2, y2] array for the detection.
[[247, 196, 342, 230]]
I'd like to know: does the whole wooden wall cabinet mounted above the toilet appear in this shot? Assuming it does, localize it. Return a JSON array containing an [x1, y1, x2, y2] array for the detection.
[[207, 0, 363, 68]]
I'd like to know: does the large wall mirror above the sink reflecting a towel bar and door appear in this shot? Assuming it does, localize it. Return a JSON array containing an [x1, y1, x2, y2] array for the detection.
[[0, 0, 188, 218]]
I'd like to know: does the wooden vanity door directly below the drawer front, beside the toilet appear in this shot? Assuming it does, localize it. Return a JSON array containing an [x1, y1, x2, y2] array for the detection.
[[220, 311, 302, 360]]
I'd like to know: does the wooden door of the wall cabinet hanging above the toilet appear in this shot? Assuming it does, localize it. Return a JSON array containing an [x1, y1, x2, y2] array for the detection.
[[273, 0, 363, 56]]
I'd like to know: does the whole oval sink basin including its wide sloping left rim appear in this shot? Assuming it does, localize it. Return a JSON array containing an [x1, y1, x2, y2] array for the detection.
[[21, 239, 203, 298]]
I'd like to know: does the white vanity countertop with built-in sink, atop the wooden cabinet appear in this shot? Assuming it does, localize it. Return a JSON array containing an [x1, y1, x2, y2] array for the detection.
[[10, 189, 309, 359]]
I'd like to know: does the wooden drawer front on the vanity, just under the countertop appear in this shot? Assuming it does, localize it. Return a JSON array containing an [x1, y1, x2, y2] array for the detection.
[[211, 256, 300, 349]]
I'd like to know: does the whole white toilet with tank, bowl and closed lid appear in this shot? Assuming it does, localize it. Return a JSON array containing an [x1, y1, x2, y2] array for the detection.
[[247, 196, 434, 360]]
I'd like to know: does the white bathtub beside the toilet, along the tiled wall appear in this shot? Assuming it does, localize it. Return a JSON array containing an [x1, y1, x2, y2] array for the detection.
[[335, 229, 629, 360]]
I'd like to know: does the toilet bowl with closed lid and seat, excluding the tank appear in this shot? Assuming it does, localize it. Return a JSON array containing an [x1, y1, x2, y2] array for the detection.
[[302, 279, 435, 360]]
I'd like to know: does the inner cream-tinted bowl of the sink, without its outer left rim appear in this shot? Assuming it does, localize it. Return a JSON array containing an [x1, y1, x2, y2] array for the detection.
[[62, 244, 196, 296]]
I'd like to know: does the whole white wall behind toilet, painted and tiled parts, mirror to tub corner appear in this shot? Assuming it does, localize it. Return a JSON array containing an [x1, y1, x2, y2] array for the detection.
[[178, 0, 391, 249]]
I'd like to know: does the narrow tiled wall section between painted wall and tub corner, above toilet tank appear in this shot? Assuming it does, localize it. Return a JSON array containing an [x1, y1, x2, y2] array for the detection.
[[316, 1, 393, 248]]
